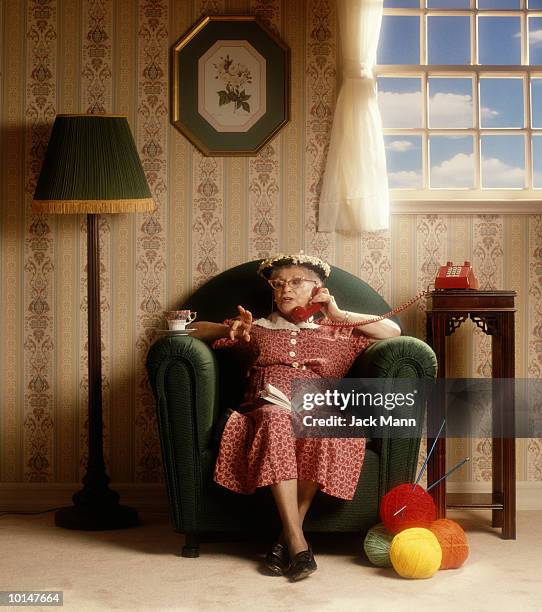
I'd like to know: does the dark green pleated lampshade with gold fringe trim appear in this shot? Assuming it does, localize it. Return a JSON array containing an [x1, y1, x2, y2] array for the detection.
[[32, 115, 155, 214]]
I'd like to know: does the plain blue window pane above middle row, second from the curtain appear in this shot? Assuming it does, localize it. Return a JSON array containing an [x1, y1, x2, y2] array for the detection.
[[427, 17, 470, 64]]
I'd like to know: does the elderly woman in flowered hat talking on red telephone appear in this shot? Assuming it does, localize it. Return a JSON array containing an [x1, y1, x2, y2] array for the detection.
[[194, 253, 401, 581]]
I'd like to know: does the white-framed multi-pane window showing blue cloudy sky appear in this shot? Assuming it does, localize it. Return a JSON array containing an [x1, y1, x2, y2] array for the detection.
[[375, 0, 542, 207]]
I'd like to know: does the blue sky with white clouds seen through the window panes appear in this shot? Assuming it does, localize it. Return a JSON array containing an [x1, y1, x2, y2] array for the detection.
[[377, 8, 542, 188]]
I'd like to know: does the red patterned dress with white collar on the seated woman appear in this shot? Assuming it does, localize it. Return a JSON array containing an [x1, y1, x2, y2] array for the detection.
[[213, 313, 370, 499]]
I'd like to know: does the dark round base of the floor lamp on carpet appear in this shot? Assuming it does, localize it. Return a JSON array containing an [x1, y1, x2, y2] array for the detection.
[[55, 504, 139, 531]]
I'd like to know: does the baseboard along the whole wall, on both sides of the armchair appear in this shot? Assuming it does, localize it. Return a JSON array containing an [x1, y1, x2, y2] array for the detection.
[[0, 481, 542, 513]]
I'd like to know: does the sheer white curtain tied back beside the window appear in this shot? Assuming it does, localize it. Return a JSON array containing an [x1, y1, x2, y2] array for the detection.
[[318, 0, 389, 232]]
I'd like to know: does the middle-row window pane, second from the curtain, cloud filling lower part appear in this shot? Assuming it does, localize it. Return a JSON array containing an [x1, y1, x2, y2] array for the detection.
[[429, 77, 472, 128]]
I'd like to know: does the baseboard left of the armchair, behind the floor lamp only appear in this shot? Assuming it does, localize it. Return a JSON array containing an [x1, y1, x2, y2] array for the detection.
[[0, 482, 169, 512]]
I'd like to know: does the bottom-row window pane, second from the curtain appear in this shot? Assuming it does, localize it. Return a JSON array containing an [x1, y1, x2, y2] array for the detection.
[[429, 136, 474, 189]]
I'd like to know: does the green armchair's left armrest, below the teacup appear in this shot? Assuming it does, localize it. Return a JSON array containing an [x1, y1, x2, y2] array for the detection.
[[147, 336, 219, 531]]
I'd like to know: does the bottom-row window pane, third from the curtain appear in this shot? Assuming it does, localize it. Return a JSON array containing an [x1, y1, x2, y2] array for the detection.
[[481, 136, 525, 189]]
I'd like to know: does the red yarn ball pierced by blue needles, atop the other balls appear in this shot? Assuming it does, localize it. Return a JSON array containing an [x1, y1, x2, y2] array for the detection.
[[380, 484, 437, 533]]
